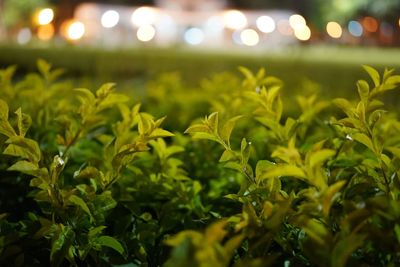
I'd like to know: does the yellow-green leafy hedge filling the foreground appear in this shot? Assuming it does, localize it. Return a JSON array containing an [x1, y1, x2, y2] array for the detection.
[[0, 60, 400, 267]]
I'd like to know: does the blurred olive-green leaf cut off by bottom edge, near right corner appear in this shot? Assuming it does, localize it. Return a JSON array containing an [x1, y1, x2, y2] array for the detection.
[[331, 233, 366, 267]]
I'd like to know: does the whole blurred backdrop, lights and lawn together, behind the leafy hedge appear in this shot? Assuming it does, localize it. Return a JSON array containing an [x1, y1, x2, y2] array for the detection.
[[0, 0, 400, 105]]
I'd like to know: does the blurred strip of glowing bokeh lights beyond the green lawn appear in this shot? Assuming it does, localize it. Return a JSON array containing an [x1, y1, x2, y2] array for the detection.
[[0, 0, 400, 47]]
